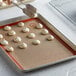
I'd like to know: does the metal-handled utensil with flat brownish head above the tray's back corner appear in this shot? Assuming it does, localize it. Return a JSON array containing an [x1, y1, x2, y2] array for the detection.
[[12, 1, 38, 17]]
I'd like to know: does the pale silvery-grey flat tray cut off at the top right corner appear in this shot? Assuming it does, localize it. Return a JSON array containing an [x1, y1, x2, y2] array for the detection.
[[49, 0, 76, 26]]
